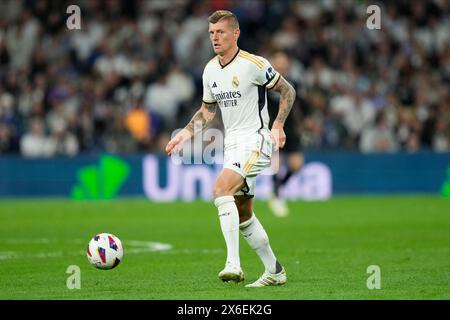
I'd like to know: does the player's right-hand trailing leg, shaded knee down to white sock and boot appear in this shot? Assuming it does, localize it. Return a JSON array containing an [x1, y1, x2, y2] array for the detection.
[[235, 195, 286, 287]]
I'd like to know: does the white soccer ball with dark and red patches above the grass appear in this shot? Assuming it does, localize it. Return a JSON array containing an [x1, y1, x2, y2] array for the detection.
[[87, 233, 123, 270]]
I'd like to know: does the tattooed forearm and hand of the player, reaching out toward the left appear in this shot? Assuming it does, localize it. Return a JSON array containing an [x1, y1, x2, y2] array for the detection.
[[166, 102, 217, 155]]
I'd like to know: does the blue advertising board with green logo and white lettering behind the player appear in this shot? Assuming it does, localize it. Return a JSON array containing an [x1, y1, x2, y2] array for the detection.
[[0, 152, 450, 201]]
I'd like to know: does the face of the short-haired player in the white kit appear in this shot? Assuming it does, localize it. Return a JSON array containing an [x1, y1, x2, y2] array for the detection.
[[209, 20, 239, 55]]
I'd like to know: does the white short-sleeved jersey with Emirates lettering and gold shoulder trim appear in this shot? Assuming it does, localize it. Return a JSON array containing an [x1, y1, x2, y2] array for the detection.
[[203, 49, 280, 146]]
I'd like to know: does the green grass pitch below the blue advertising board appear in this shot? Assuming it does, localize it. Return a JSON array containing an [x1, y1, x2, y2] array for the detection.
[[0, 196, 450, 300]]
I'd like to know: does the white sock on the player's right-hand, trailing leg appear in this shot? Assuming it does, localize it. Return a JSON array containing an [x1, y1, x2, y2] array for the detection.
[[239, 213, 279, 273]]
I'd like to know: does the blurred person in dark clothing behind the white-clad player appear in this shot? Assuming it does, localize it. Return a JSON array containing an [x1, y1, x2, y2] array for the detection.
[[267, 51, 304, 217]]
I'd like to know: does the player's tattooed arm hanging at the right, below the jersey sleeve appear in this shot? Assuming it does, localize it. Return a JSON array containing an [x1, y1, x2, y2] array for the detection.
[[271, 75, 296, 148]]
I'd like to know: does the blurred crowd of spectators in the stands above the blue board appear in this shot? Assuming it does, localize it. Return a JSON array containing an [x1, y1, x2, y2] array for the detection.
[[0, 0, 450, 157]]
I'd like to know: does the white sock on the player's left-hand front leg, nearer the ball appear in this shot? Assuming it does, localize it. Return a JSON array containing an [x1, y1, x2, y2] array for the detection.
[[214, 196, 241, 267]]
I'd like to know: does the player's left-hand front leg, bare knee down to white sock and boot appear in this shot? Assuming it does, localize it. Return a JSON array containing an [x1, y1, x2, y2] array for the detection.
[[213, 168, 244, 282]]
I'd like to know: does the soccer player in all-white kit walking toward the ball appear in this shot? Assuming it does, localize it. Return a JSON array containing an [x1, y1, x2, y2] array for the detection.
[[166, 10, 296, 287]]
